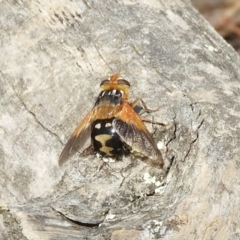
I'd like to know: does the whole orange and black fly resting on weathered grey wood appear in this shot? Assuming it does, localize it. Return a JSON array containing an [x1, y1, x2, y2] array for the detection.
[[59, 74, 163, 168]]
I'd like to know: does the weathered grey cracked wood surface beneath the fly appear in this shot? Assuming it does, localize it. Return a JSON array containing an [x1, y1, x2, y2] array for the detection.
[[0, 0, 240, 240]]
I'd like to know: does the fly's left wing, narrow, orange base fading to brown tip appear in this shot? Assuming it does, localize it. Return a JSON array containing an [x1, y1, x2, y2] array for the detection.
[[58, 111, 93, 166]]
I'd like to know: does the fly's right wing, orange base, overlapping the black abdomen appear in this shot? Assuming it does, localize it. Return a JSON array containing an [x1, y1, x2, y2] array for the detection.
[[113, 103, 163, 168]]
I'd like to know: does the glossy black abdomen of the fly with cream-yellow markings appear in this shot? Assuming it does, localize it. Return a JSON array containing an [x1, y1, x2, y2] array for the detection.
[[91, 118, 130, 158]]
